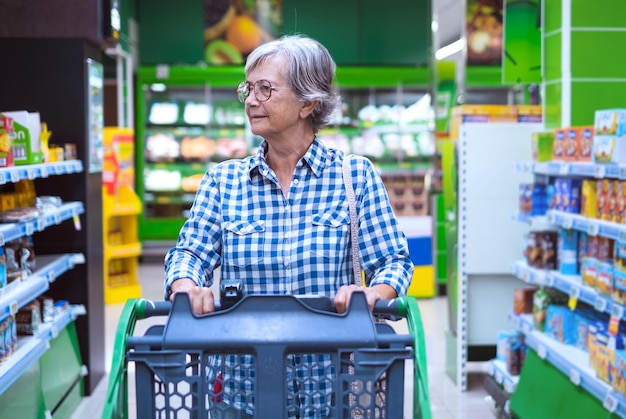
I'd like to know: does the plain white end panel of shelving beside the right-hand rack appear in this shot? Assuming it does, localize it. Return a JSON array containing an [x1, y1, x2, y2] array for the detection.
[[446, 123, 542, 391]]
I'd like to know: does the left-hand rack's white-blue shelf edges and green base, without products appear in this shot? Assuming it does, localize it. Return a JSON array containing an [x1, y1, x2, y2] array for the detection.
[[0, 160, 88, 417]]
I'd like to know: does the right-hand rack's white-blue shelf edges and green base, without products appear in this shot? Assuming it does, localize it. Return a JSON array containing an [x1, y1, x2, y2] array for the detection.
[[509, 162, 626, 418]]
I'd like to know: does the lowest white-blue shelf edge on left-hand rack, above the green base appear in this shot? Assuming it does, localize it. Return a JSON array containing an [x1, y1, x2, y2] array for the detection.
[[0, 305, 85, 394]]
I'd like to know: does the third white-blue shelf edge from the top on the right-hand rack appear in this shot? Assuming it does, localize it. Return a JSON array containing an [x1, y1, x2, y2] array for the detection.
[[513, 261, 626, 319]]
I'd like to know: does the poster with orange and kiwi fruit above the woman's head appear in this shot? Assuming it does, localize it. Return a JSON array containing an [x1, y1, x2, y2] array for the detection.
[[204, 0, 282, 65]]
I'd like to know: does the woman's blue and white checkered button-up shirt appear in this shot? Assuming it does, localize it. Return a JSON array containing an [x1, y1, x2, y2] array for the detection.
[[165, 138, 413, 417]]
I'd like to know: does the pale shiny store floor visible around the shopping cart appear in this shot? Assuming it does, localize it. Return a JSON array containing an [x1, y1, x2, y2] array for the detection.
[[71, 263, 496, 419]]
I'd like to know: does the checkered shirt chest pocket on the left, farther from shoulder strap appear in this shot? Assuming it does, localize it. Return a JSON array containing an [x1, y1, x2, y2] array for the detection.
[[222, 220, 265, 266]]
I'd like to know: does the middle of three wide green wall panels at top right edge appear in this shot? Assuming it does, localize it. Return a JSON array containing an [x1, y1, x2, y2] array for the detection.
[[570, 30, 626, 78]]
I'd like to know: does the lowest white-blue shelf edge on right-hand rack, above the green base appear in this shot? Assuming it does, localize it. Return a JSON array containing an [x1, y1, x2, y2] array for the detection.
[[510, 314, 626, 418]]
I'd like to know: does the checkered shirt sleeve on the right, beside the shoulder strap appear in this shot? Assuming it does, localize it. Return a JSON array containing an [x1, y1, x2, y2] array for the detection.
[[353, 157, 413, 296]]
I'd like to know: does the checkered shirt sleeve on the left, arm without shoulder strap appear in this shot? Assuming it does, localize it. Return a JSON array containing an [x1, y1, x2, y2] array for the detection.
[[165, 172, 222, 299]]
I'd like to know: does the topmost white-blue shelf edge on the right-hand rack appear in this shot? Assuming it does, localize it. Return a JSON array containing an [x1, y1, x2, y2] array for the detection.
[[516, 161, 626, 179]]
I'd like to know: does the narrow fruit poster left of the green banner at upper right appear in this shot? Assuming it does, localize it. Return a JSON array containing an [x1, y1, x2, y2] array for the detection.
[[466, 0, 503, 66]]
